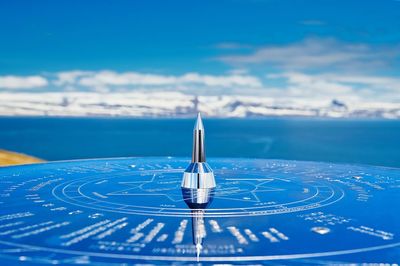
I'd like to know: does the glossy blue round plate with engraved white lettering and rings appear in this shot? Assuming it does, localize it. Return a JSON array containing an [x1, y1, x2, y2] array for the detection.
[[0, 157, 400, 265]]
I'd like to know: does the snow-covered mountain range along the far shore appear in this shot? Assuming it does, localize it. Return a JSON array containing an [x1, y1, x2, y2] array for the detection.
[[0, 91, 400, 119]]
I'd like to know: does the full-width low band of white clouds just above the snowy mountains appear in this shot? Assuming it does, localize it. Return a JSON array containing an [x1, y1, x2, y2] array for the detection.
[[0, 68, 400, 108]]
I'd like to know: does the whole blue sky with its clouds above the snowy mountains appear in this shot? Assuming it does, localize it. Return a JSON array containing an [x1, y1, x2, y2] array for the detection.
[[0, 0, 400, 101]]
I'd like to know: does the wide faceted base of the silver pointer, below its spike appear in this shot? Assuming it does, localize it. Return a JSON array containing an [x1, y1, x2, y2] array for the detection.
[[181, 162, 216, 189]]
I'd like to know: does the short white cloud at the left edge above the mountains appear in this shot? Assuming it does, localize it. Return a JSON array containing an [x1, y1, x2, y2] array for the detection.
[[0, 76, 48, 89]]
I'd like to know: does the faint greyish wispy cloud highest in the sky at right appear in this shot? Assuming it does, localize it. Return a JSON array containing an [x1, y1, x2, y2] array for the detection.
[[216, 38, 400, 69]]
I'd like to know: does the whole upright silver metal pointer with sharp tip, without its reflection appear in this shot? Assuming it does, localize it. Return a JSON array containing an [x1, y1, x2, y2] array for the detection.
[[181, 113, 216, 189]]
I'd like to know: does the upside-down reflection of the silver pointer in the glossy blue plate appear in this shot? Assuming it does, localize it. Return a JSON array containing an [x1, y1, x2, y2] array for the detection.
[[182, 188, 214, 261]]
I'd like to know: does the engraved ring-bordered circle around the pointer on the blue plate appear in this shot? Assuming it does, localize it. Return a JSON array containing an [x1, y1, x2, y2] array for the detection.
[[53, 166, 344, 217]]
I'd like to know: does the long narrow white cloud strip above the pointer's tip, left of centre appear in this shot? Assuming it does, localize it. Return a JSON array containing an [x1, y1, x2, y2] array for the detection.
[[54, 71, 262, 88]]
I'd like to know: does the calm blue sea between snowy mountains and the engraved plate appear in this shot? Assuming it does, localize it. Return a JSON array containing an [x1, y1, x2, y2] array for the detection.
[[0, 117, 400, 167]]
